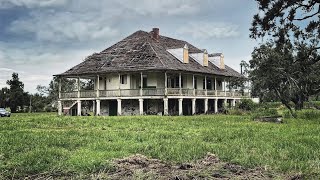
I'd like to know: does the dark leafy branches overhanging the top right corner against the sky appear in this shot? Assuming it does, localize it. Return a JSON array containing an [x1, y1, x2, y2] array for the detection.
[[250, 0, 320, 49]]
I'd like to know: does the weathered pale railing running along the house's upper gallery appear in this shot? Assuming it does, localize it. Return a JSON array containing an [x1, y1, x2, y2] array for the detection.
[[61, 88, 249, 99]]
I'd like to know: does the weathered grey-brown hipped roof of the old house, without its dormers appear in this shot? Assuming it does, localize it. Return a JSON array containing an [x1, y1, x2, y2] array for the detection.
[[56, 31, 242, 77]]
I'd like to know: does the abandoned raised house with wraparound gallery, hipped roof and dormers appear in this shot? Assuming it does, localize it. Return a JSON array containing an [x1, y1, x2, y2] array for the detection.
[[55, 28, 249, 116]]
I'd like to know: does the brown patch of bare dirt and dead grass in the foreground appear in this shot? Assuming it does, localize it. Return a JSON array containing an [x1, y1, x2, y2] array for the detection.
[[104, 154, 279, 180]]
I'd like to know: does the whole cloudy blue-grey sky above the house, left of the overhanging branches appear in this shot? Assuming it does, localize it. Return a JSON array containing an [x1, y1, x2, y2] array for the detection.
[[0, 0, 258, 93]]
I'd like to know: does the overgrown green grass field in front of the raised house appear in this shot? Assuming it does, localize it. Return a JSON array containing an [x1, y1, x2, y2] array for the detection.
[[0, 114, 320, 179]]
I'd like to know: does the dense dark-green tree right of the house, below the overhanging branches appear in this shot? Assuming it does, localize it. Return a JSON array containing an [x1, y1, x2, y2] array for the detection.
[[249, 42, 320, 114]]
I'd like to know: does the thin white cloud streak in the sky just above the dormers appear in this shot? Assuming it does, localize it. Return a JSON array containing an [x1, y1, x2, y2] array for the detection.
[[178, 22, 240, 39]]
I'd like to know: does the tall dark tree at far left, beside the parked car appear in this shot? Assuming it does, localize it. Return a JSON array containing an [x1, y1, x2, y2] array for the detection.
[[7, 73, 25, 112]]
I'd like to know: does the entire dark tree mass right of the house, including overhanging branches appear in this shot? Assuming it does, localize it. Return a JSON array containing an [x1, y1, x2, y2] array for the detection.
[[250, 0, 320, 111]]
